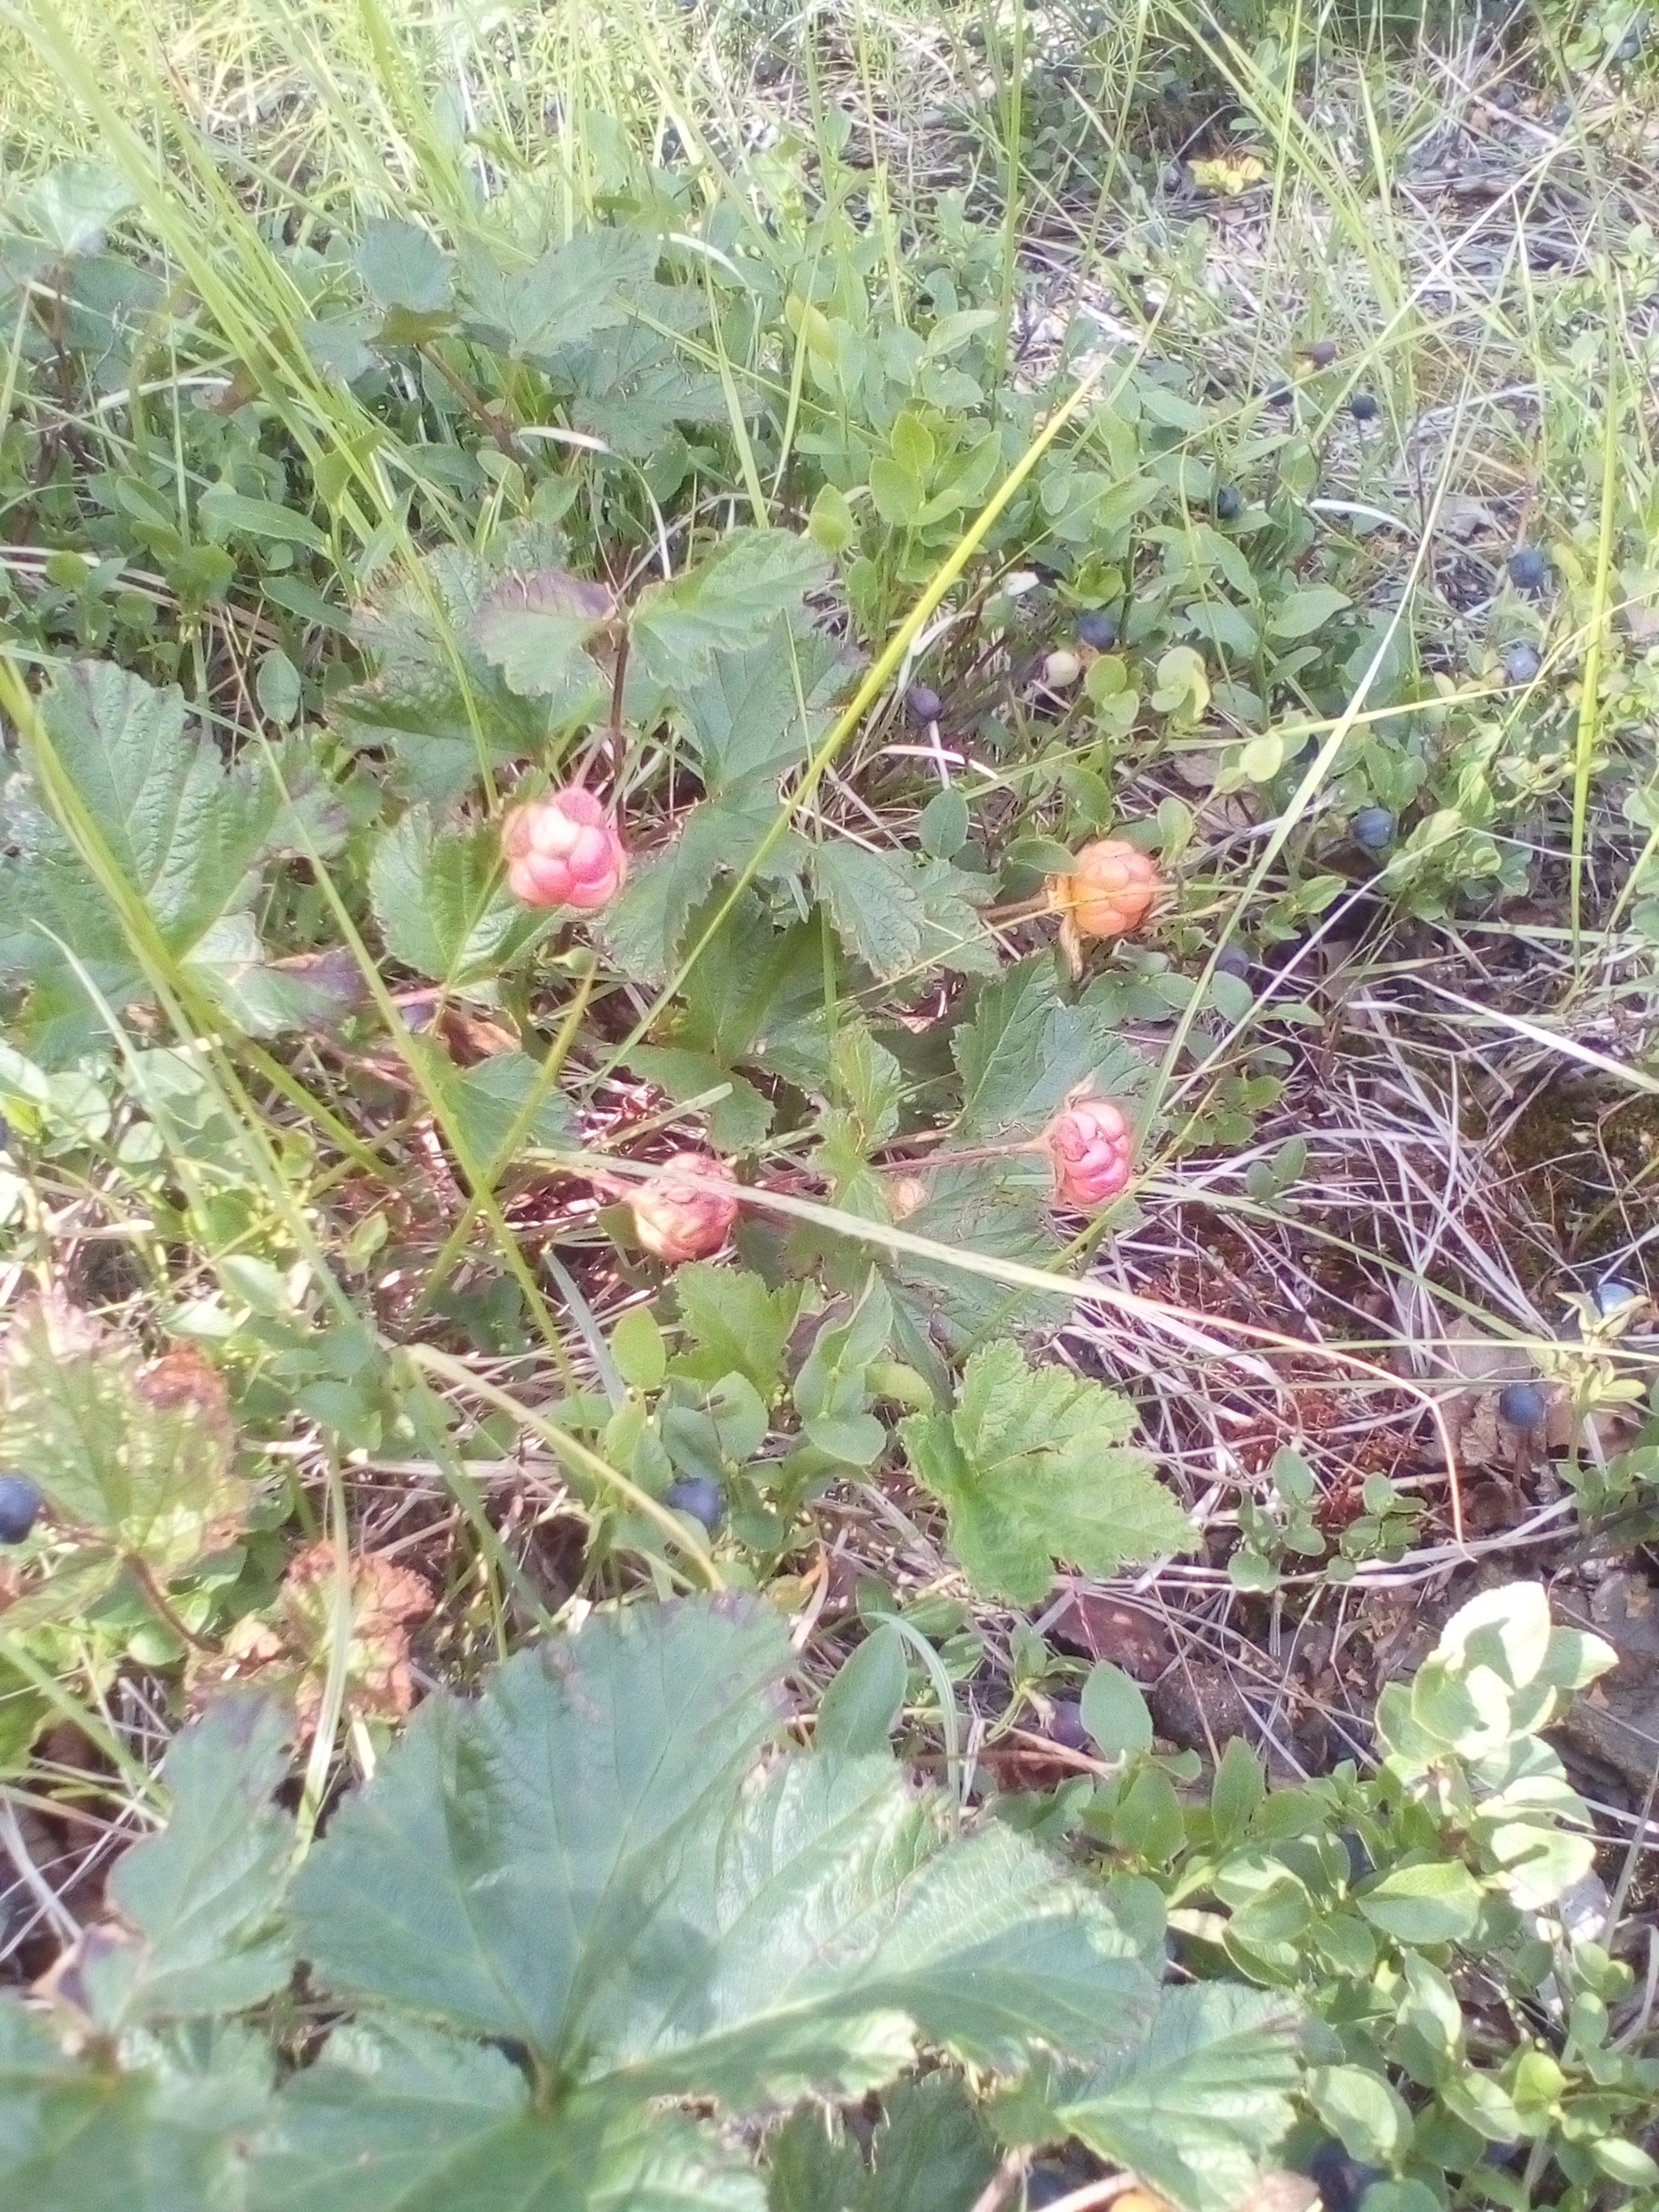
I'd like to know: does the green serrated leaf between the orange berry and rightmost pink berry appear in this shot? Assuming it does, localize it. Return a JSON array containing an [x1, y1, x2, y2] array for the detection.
[[951, 953, 1148, 1144]]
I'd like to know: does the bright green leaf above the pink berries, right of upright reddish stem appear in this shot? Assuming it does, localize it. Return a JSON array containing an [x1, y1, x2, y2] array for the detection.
[[630, 529, 827, 690]]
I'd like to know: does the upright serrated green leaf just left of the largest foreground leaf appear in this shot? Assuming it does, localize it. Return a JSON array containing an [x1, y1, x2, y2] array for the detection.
[[79, 1697, 294, 2033]]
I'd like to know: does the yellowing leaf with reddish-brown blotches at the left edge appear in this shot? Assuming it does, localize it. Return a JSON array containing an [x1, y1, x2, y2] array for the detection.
[[0, 1298, 252, 1582]]
